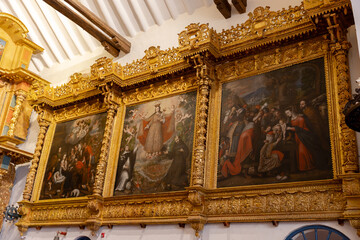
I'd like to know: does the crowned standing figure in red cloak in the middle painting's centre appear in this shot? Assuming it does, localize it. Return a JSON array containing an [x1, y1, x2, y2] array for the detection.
[[138, 104, 175, 157]]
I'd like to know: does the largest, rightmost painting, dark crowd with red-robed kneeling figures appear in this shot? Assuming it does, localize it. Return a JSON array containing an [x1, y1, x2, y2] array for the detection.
[[217, 58, 332, 187]]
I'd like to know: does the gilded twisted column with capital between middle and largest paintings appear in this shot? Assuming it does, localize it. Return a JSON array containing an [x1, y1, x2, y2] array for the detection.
[[192, 55, 212, 187]]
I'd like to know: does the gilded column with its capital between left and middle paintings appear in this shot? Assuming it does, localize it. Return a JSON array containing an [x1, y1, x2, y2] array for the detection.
[[93, 84, 120, 196]]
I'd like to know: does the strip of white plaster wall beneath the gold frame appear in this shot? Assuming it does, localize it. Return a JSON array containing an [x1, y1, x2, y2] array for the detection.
[[16, 221, 359, 240]]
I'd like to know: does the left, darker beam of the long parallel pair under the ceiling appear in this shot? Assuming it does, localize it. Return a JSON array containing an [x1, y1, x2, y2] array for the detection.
[[44, 0, 131, 57]]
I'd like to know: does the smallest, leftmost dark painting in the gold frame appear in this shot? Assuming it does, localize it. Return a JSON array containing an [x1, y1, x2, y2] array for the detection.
[[40, 113, 106, 200]]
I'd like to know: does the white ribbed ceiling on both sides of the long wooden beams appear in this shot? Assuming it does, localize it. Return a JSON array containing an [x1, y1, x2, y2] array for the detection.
[[0, 0, 214, 73]]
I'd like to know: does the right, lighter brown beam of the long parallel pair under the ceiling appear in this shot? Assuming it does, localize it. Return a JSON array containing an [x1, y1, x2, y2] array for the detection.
[[65, 0, 131, 53]]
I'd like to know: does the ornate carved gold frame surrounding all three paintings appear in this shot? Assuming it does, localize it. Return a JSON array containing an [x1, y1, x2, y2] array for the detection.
[[17, 0, 360, 235]]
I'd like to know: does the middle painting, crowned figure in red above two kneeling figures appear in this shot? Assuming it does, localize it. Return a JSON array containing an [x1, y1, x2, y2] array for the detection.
[[114, 92, 196, 195]]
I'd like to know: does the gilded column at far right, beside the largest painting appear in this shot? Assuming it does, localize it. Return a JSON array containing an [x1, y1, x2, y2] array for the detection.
[[324, 14, 360, 236]]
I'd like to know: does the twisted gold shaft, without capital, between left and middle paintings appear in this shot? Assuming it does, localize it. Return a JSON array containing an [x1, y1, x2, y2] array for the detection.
[[93, 103, 118, 196]]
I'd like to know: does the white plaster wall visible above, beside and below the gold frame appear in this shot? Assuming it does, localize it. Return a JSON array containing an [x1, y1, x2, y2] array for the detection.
[[0, 0, 360, 240]]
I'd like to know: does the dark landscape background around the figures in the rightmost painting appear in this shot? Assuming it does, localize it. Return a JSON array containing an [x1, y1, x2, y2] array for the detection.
[[217, 58, 332, 187]]
